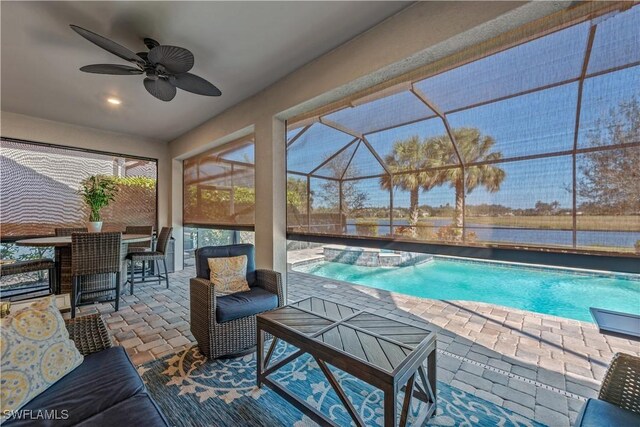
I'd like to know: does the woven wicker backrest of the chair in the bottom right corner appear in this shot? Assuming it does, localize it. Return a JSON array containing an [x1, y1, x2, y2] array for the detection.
[[598, 353, 640, 413]]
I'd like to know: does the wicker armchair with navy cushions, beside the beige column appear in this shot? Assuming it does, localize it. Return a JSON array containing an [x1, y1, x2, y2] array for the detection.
[[189, 244, 284, 359]]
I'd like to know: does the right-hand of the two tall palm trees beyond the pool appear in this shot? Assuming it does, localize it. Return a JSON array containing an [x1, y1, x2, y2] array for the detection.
[[432, 128, 506, 230]]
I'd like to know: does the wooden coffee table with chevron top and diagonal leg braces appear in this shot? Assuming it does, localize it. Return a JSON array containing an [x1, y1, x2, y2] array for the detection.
[[257, 297, 436, 427]]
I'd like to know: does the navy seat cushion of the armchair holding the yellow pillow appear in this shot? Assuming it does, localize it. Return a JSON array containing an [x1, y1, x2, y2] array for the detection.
[[216, 287, 278, 323]]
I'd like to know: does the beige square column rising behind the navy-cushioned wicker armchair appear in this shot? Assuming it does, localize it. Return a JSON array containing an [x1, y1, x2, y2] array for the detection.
[[255, 117, 287, 295]]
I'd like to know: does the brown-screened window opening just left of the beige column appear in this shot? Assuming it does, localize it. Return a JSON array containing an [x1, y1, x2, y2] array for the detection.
[[183, 137, 255, 230]]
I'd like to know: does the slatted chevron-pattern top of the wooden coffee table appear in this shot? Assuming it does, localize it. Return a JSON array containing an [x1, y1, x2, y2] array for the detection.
[[258, 297, 436, 376]]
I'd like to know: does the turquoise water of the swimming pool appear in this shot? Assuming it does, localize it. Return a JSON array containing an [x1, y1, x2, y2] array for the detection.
[[294, 259, 640, 322]]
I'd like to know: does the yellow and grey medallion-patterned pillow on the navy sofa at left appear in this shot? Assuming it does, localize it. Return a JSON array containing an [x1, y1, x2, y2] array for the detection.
[[0, 296, 84, 414]]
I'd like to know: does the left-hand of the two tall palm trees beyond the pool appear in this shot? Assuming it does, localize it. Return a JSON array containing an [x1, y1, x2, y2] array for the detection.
[[380, 135, 441, 237]]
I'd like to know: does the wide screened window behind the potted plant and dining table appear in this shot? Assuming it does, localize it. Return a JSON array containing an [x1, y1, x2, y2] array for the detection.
[[0, 138, 157, 241]]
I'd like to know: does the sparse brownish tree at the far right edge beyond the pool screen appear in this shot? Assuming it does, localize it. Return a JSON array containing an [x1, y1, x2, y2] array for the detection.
[[577, 96, 640, 214]]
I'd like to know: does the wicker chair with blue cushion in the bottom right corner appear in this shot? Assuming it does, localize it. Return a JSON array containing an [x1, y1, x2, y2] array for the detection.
[[576, 353, 640, 427]]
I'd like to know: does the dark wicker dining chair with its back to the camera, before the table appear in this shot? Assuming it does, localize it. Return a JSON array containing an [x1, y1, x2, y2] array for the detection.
[[71, 233, 122, 318]]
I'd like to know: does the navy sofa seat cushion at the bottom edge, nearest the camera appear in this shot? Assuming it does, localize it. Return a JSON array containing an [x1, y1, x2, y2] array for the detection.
[[77, 392, 169, 427]]
